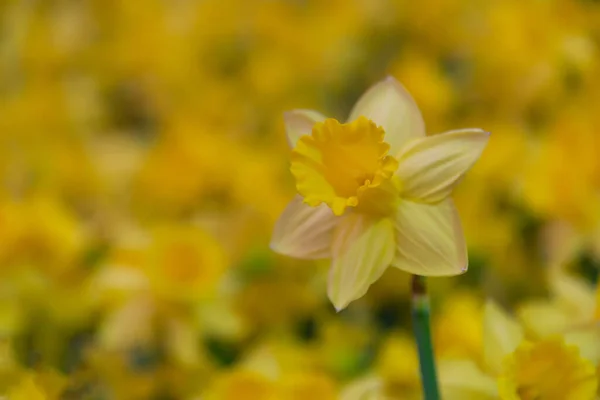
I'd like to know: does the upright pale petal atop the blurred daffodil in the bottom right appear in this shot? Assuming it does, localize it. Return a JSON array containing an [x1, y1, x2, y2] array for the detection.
[[483, 300, 523, 373]]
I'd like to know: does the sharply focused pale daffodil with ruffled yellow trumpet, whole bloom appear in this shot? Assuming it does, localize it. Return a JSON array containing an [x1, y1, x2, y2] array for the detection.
[[271, 78, 489, 310]]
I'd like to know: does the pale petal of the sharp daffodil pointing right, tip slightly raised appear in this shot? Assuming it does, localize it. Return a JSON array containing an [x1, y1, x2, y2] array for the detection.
[[396, 129, 489, 203]]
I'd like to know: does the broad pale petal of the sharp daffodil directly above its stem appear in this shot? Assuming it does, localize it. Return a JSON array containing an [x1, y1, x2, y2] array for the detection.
[[393, 199, 468, 276]]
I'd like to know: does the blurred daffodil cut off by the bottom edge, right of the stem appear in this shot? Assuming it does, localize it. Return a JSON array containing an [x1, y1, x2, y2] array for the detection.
[[440, 302, 598, 400]]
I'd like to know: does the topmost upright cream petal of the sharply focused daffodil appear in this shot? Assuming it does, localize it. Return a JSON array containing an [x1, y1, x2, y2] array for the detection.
[[348, 76, 425, 155]]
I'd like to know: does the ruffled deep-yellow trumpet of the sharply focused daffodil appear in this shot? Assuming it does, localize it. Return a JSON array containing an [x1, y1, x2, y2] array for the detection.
[[291, 117, 398, 215]]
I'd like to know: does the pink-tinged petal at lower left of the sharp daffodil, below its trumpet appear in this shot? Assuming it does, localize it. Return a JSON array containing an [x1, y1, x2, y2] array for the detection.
[[271, 196, 339, 260]]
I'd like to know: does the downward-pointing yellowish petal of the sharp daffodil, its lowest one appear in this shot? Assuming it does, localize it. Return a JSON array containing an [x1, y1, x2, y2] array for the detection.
[[327, 213, 395, 311]]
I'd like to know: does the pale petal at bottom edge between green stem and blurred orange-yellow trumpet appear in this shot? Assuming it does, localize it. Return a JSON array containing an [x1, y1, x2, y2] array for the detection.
[[438, 360, 498, 400]]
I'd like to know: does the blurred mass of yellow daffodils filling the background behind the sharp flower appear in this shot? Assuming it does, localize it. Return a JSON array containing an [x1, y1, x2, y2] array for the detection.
[[0, 0, 600, 400]]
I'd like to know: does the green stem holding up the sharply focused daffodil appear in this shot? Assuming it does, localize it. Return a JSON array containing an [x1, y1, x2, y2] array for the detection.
[[411, 275, 440, 400]]
